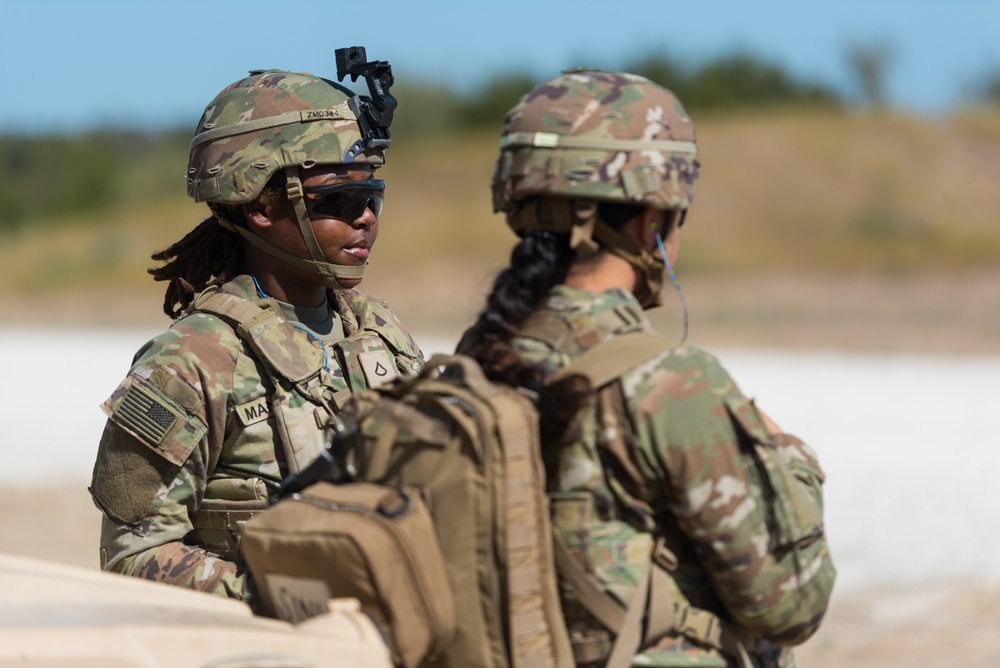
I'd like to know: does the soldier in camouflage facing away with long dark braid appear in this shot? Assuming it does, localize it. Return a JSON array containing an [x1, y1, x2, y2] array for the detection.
[[459, 70, 835, 667]]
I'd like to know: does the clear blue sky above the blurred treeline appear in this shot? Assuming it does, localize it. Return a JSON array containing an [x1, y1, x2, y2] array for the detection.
[[0, 0, 1000, 132]]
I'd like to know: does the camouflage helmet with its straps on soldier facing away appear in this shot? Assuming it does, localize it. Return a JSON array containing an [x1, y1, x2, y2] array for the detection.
[[492, 69, 700, 308]]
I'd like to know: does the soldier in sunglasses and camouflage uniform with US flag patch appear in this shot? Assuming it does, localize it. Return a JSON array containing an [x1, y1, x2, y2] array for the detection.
[[90, 53, 423, 602]]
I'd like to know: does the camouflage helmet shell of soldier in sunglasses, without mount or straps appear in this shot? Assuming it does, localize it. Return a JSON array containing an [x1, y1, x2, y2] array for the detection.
[[187, 70, 385, 204]]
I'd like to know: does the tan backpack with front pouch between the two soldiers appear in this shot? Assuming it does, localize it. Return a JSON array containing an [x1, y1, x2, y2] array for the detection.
[[242, 355, 574, 668]]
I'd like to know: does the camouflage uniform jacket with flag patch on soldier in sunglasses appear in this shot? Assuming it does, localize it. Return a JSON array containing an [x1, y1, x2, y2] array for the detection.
[[90, 276, 423, 600]]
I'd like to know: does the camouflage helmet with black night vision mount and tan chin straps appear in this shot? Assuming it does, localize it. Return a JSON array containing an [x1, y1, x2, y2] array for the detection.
[[187, 46, 396, 289]]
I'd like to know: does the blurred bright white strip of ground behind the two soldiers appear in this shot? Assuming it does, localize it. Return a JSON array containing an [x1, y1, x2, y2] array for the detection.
[[0, 328, 1000, 590]]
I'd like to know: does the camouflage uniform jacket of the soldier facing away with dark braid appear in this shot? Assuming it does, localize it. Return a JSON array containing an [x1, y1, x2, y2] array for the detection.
[[513, 285, 834, 666]]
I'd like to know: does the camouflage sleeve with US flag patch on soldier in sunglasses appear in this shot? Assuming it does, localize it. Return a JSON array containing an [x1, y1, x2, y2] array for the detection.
[[90, 318, 245, 598]]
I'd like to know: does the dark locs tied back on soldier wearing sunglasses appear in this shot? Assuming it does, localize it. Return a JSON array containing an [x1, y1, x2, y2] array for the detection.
[[146, 172, 287, 319]]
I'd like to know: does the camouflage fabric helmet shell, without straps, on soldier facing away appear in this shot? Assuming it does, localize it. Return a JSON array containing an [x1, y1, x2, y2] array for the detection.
[[492, 70, 700, 217]]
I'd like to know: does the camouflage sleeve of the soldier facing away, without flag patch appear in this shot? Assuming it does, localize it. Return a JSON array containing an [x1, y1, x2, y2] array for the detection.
[[623, 349, 834, 644]]
